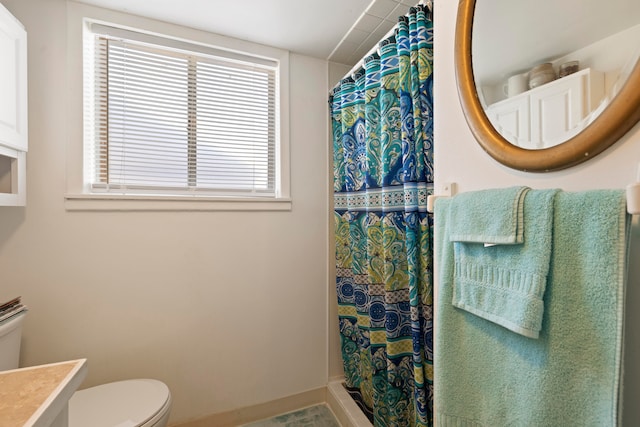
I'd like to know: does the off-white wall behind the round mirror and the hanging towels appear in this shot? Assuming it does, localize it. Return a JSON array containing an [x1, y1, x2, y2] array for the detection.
[[434, 1, 640, 426]]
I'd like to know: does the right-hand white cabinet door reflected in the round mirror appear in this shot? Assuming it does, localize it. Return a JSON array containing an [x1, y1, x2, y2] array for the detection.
[[530, 75, 588, 148]]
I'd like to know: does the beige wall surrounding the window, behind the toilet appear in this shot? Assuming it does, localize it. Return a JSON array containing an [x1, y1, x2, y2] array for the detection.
[[0, 0, 329, 422]]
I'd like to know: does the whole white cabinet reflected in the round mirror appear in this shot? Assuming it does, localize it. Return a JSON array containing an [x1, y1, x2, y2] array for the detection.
[[487, 69, 605, 149]]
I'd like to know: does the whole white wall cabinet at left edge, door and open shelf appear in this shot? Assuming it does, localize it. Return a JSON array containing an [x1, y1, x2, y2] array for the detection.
[[0, 4, 28, 206]]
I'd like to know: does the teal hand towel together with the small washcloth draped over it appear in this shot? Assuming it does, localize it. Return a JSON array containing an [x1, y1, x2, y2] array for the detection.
[[447, 187, 557, 338]]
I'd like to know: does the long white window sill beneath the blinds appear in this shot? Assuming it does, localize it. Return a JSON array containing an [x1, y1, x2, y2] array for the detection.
[[65, 194, 292, 211]]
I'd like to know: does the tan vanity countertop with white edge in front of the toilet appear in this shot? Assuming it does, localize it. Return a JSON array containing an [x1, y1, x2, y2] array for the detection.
[[0, 359, 87, 427]]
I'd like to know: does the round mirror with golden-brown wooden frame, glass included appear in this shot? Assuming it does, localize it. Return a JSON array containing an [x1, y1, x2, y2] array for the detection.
[[455, 0, 640, 172]]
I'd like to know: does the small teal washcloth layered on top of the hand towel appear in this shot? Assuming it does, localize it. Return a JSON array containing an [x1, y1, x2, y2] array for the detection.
[[449, 187, 529, 244]]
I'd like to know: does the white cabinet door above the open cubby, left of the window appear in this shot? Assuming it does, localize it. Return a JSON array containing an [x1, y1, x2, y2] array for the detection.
[[0, 4, 27, 151]]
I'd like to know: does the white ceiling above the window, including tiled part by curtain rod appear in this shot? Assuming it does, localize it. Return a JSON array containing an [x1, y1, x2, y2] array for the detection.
[[72, 0, 418, 65]]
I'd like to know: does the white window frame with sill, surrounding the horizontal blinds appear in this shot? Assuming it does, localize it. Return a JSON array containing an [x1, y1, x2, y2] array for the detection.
[[65, 2, 292, 211]]
